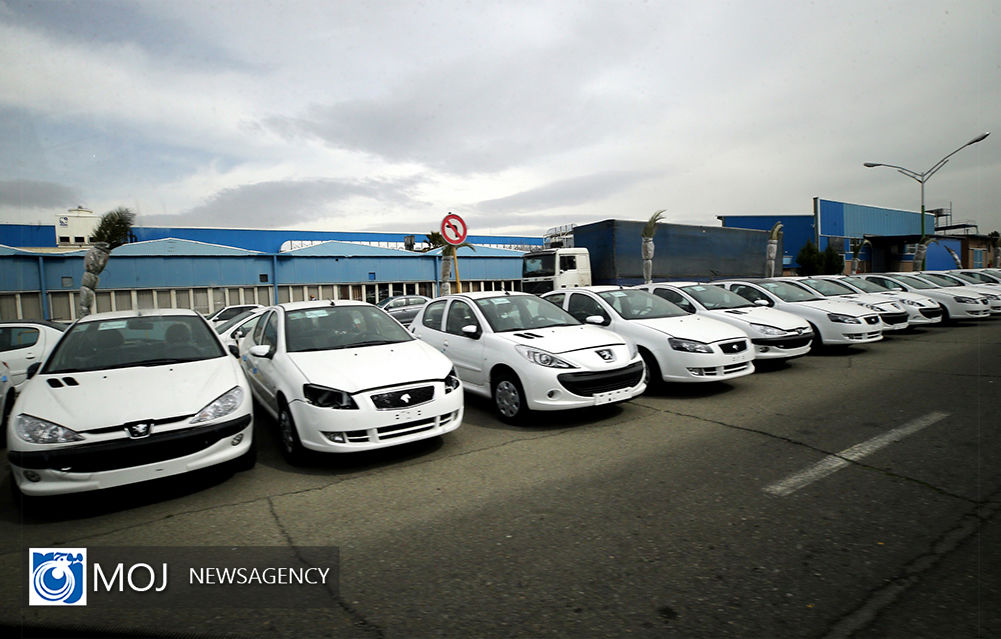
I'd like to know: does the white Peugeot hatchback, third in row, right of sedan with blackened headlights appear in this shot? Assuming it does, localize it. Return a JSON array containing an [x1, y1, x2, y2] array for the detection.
[[410, 291, 647, 423]]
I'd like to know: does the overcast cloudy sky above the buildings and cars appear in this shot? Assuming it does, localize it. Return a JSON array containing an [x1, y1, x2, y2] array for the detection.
[[0, 0, 1001, 240]]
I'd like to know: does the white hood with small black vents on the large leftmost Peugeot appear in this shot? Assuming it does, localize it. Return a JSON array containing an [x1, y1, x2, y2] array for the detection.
[[15, 356, 249, 433]]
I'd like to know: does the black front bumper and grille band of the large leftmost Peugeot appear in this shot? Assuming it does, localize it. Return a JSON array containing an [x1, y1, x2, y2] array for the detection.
[[7, 415, 251, 473]]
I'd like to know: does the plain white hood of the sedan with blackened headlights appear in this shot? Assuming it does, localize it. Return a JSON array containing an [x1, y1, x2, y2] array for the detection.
[[286, 340, 451, 393]]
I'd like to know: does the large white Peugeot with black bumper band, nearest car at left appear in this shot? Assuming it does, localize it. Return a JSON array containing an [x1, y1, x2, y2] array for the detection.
[[7, 308, 255, 496]]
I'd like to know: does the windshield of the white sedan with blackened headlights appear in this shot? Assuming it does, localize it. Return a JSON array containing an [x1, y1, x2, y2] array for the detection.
[[285, 305, 413, 353]]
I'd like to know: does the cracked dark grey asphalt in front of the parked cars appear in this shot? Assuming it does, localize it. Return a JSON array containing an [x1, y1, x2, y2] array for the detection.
[[0, 322, 1001, 637]]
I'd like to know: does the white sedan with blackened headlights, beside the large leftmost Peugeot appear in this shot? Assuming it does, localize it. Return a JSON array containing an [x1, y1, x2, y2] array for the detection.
[[239, 299, 462, 464]]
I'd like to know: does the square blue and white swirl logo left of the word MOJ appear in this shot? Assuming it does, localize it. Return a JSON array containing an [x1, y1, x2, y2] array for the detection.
[[28, 548, 87, 606]]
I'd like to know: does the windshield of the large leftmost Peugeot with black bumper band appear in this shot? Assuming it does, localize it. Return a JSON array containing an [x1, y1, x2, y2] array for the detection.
[[42, 315, 225, 374]]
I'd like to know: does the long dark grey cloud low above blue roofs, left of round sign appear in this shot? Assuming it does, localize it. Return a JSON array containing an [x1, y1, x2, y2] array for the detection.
[[141, 179, 422, 228]]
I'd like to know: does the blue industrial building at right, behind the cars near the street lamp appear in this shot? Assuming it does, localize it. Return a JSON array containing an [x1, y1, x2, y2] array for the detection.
[[718, 197, 962, 271]]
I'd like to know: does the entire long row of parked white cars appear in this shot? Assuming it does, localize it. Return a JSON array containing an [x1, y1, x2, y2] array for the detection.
[[0, 269, 1001, 496]]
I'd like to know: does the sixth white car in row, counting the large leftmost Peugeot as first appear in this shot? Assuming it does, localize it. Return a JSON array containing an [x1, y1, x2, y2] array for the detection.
[[713, 278, 883, 346]]
